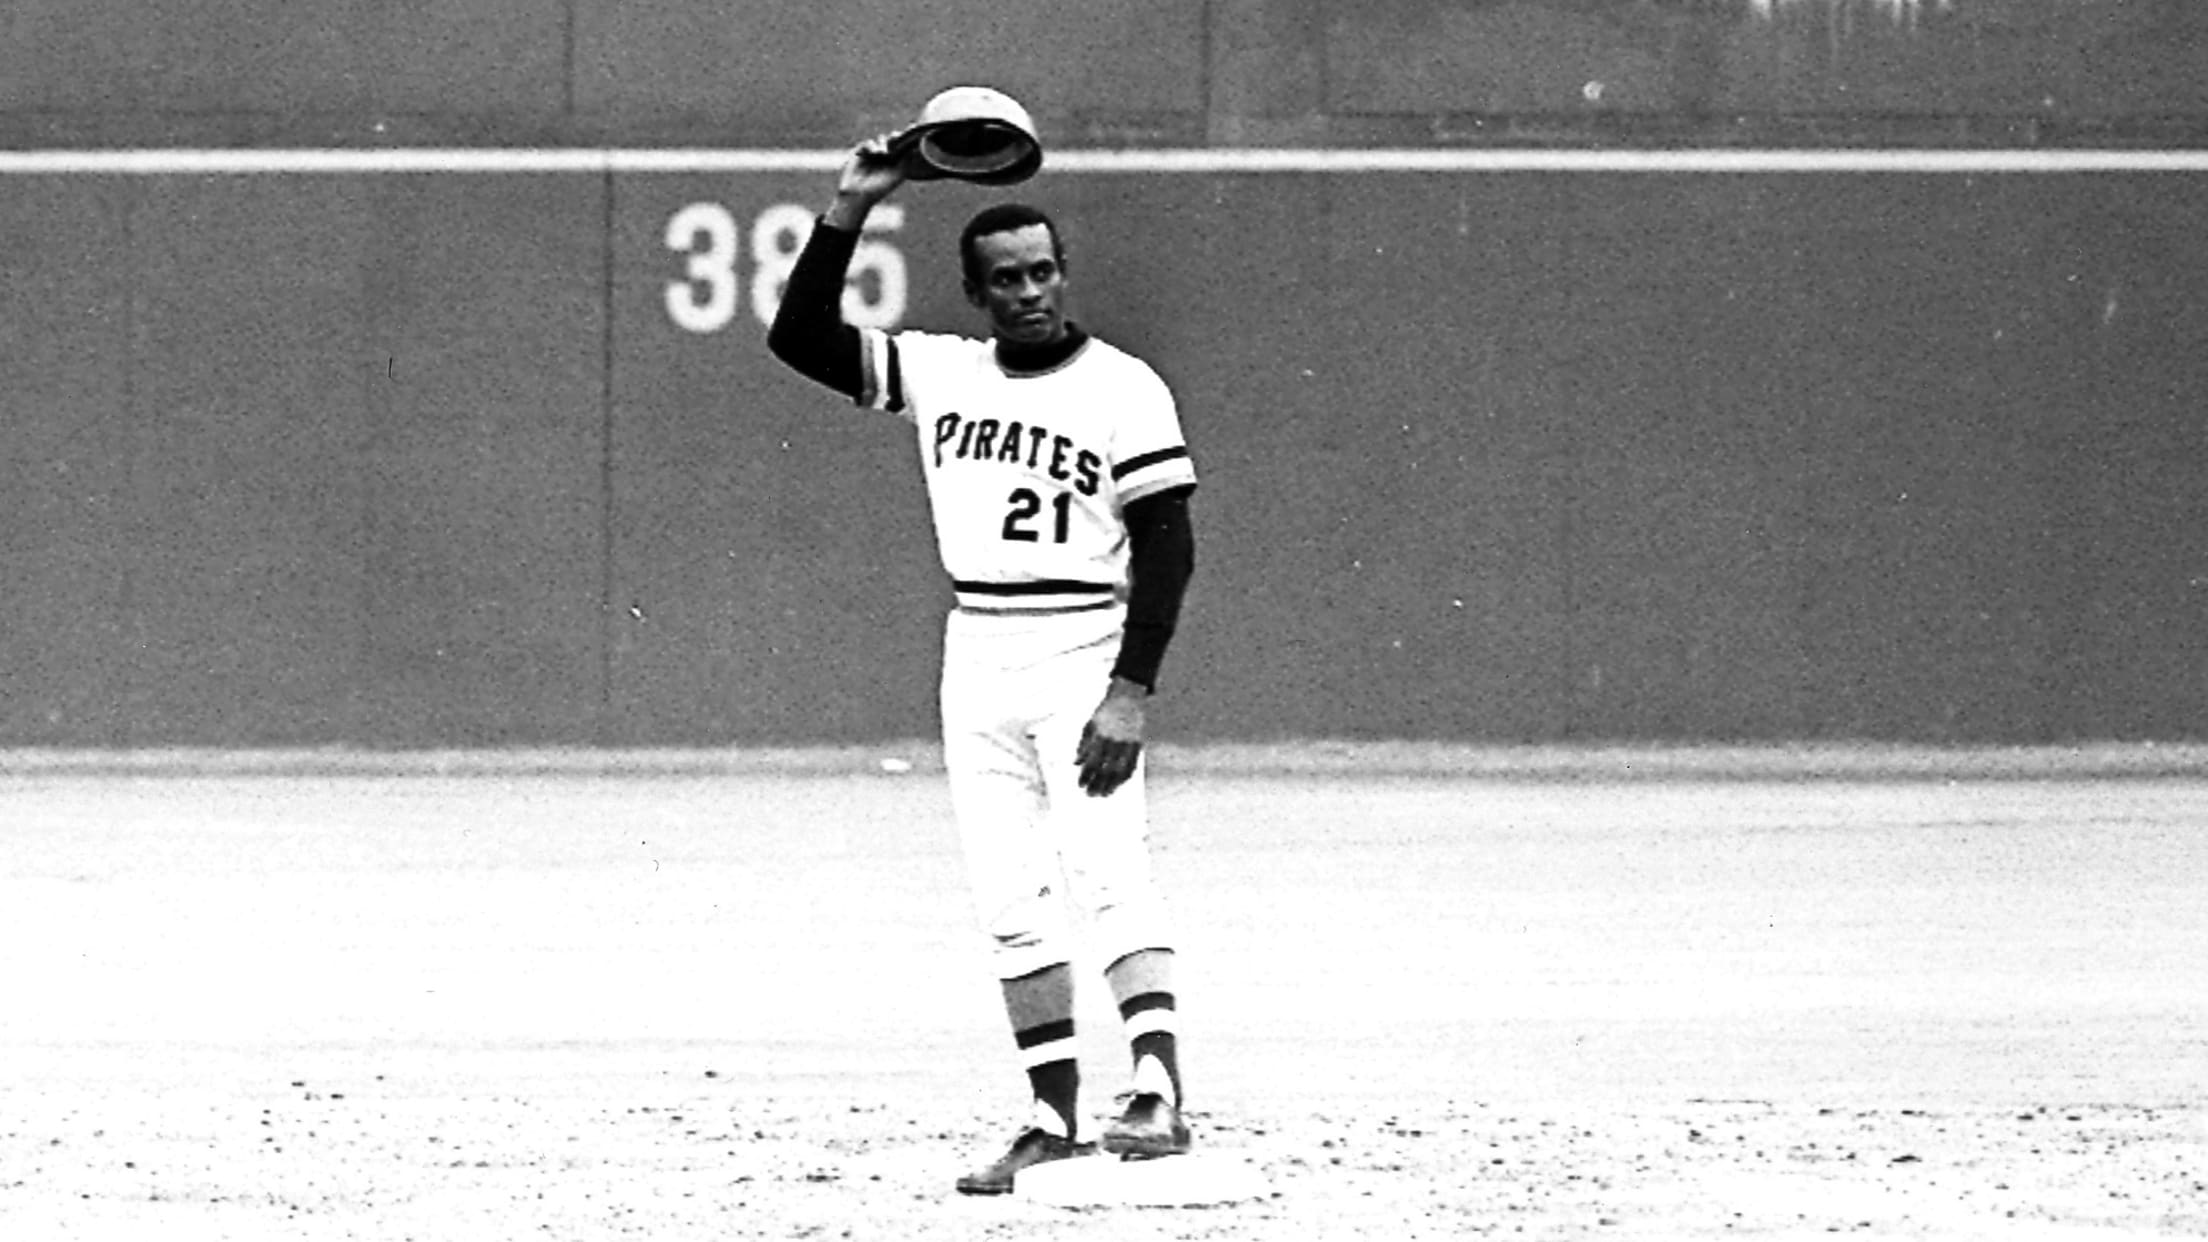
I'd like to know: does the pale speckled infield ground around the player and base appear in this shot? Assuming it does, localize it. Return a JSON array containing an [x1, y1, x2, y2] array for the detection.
[[0, 760, 2208, 1242]]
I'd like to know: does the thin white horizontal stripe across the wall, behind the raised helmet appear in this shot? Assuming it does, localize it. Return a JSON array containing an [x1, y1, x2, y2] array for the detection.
[[0, 148, 2208, 177]]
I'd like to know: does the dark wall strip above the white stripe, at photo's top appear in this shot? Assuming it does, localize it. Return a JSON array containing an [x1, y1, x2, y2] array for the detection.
[[0, 0, 2208, 148]]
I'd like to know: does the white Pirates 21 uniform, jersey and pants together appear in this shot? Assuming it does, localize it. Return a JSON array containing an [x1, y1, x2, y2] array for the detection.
[[859, 329, 1197, 979]]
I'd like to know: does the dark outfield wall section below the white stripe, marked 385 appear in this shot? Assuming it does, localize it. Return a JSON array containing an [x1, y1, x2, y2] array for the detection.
[[0, 152, 2208, 733]]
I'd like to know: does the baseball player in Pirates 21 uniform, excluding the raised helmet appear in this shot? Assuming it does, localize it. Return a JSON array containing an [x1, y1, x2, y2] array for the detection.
[[768, 139, 1197, 1193]]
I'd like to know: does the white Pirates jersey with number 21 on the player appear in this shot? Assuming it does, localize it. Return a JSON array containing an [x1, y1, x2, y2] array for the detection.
[[857, 329, 1197, 612]]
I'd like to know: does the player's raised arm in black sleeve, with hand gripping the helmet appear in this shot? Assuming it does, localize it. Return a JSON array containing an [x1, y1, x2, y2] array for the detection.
[[766, 137, 905, 400]]
